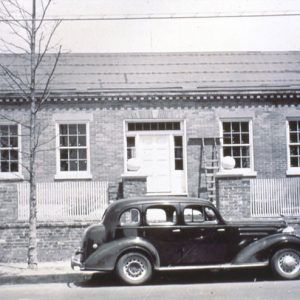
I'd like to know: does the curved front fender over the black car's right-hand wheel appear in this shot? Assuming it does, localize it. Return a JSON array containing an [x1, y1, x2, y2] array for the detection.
[[232, 233, 300, 264]]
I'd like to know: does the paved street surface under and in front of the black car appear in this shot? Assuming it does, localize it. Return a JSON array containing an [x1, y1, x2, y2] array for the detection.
[[0, 271, 300, 300]]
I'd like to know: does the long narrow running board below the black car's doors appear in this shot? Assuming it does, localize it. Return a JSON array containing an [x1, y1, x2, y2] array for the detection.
[[156, 261, 269, 271]]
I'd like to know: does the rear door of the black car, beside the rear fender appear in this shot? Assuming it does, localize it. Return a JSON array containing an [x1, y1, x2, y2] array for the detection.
[[143, 204, 182, 266]]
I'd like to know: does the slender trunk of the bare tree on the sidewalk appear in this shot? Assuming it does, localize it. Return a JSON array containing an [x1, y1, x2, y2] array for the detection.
[[27, 0, 38, 269]]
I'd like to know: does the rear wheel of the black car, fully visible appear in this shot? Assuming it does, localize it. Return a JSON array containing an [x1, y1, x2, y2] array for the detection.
[[116, 252, 153, 285]]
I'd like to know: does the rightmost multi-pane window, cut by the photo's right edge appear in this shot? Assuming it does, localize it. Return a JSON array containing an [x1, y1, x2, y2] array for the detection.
[[288, 120, 300, 168]]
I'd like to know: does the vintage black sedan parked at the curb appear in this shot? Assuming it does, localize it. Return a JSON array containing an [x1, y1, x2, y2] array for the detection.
[[71, 197, 300, 285]]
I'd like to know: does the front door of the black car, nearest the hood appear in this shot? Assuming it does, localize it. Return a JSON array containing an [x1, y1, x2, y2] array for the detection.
[[181, 204, 240, 265]]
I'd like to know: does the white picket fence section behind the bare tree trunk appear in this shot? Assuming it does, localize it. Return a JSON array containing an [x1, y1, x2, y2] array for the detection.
[[18, 181, 108, 221]]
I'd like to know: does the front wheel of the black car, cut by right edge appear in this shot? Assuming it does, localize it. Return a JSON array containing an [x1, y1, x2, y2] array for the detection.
[[271, 249, 300, 279]]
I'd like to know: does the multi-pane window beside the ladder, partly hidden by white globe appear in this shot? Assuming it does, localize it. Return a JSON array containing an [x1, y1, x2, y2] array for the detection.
[[221, 120, 253, 169]]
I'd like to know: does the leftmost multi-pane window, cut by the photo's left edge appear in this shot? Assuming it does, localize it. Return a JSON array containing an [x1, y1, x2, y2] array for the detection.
[[0, 125, 20, 173]]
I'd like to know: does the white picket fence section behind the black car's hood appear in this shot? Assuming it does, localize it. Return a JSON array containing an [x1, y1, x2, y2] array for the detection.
[[250, 178, 300, 217]]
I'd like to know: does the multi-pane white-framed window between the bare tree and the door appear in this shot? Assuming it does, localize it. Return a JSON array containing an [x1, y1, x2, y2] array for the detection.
[[58, 123, 89, 172]]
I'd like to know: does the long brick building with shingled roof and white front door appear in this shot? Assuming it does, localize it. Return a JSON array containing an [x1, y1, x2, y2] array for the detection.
[[0, 52, 300, 260]]
